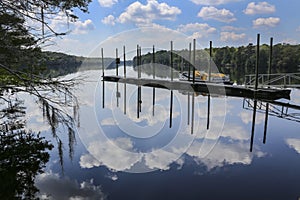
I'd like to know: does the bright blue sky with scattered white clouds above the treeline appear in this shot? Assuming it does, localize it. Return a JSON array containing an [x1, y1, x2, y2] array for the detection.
[[47, 0, 300, 56]]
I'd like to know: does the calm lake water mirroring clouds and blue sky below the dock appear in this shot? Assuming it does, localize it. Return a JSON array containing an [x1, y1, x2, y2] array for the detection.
[[19, 69, 300, 200]]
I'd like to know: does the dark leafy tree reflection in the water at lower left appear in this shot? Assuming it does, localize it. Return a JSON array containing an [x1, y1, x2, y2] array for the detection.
[[0, 98, 53, 199]]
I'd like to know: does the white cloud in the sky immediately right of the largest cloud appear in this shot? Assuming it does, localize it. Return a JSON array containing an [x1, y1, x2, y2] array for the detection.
[[198, 6, 236, 23]]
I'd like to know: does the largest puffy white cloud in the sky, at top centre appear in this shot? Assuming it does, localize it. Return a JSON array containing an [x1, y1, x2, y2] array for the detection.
[[118, 0, 181, 24]]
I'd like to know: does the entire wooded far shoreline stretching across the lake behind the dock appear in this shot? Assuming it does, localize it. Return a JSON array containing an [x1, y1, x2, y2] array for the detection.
[[43, 44, 300, 83]]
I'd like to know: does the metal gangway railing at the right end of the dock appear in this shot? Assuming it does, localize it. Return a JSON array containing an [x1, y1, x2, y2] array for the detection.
[[245, 73, 300, 88]]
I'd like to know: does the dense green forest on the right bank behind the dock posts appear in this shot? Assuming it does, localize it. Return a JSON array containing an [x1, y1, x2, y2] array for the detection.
[[133, 44, 300, 83]]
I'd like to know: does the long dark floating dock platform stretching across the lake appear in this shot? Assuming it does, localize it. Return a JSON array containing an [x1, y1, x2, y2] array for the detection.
[[103, 76, 291, 100]]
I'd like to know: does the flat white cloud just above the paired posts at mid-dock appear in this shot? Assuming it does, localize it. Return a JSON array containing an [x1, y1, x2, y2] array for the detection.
[[177, 23, 217, 39]]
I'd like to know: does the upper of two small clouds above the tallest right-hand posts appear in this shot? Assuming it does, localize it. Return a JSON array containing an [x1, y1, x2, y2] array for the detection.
[[244, 1, 276, 15]]
